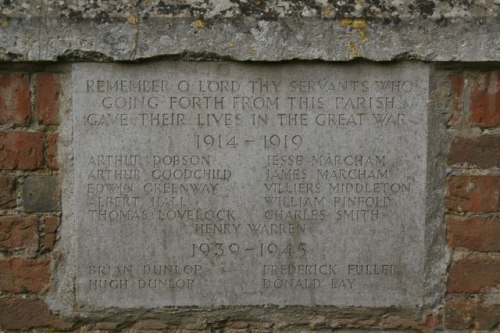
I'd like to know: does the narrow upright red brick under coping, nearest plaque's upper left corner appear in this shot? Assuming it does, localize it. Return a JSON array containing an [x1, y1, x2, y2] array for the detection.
[[35, 73, 59, 125]]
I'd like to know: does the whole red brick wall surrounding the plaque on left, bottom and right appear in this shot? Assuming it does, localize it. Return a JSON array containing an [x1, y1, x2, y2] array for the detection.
[[0, 69, 500, 333]]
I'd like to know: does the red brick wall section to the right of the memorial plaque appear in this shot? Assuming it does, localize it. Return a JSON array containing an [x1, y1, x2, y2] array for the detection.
[[444, 71, 500, 330]]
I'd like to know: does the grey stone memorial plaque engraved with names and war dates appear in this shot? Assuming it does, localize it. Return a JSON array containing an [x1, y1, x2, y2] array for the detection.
[[72, 61, 429, 308]]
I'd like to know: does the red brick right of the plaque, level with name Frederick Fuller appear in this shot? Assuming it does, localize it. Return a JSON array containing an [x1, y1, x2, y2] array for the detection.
[[448, 259, 500, 293]]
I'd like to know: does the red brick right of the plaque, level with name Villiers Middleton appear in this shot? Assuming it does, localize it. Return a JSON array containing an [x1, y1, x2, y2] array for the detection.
[[446, 176, 500, 212]]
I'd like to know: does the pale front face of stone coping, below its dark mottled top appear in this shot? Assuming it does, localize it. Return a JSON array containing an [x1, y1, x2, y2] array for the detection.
[[0, 16, 500, 62]]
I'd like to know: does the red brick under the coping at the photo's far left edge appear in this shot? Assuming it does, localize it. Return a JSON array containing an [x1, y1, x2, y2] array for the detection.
[[0, 73, 30, 125]]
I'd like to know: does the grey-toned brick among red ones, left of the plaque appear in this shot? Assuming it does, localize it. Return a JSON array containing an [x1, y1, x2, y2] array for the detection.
[[23, 176, 61, 212]]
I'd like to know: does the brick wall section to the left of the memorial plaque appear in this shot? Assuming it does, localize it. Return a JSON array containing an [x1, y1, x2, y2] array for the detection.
[[0, 72, 69, 329]]
